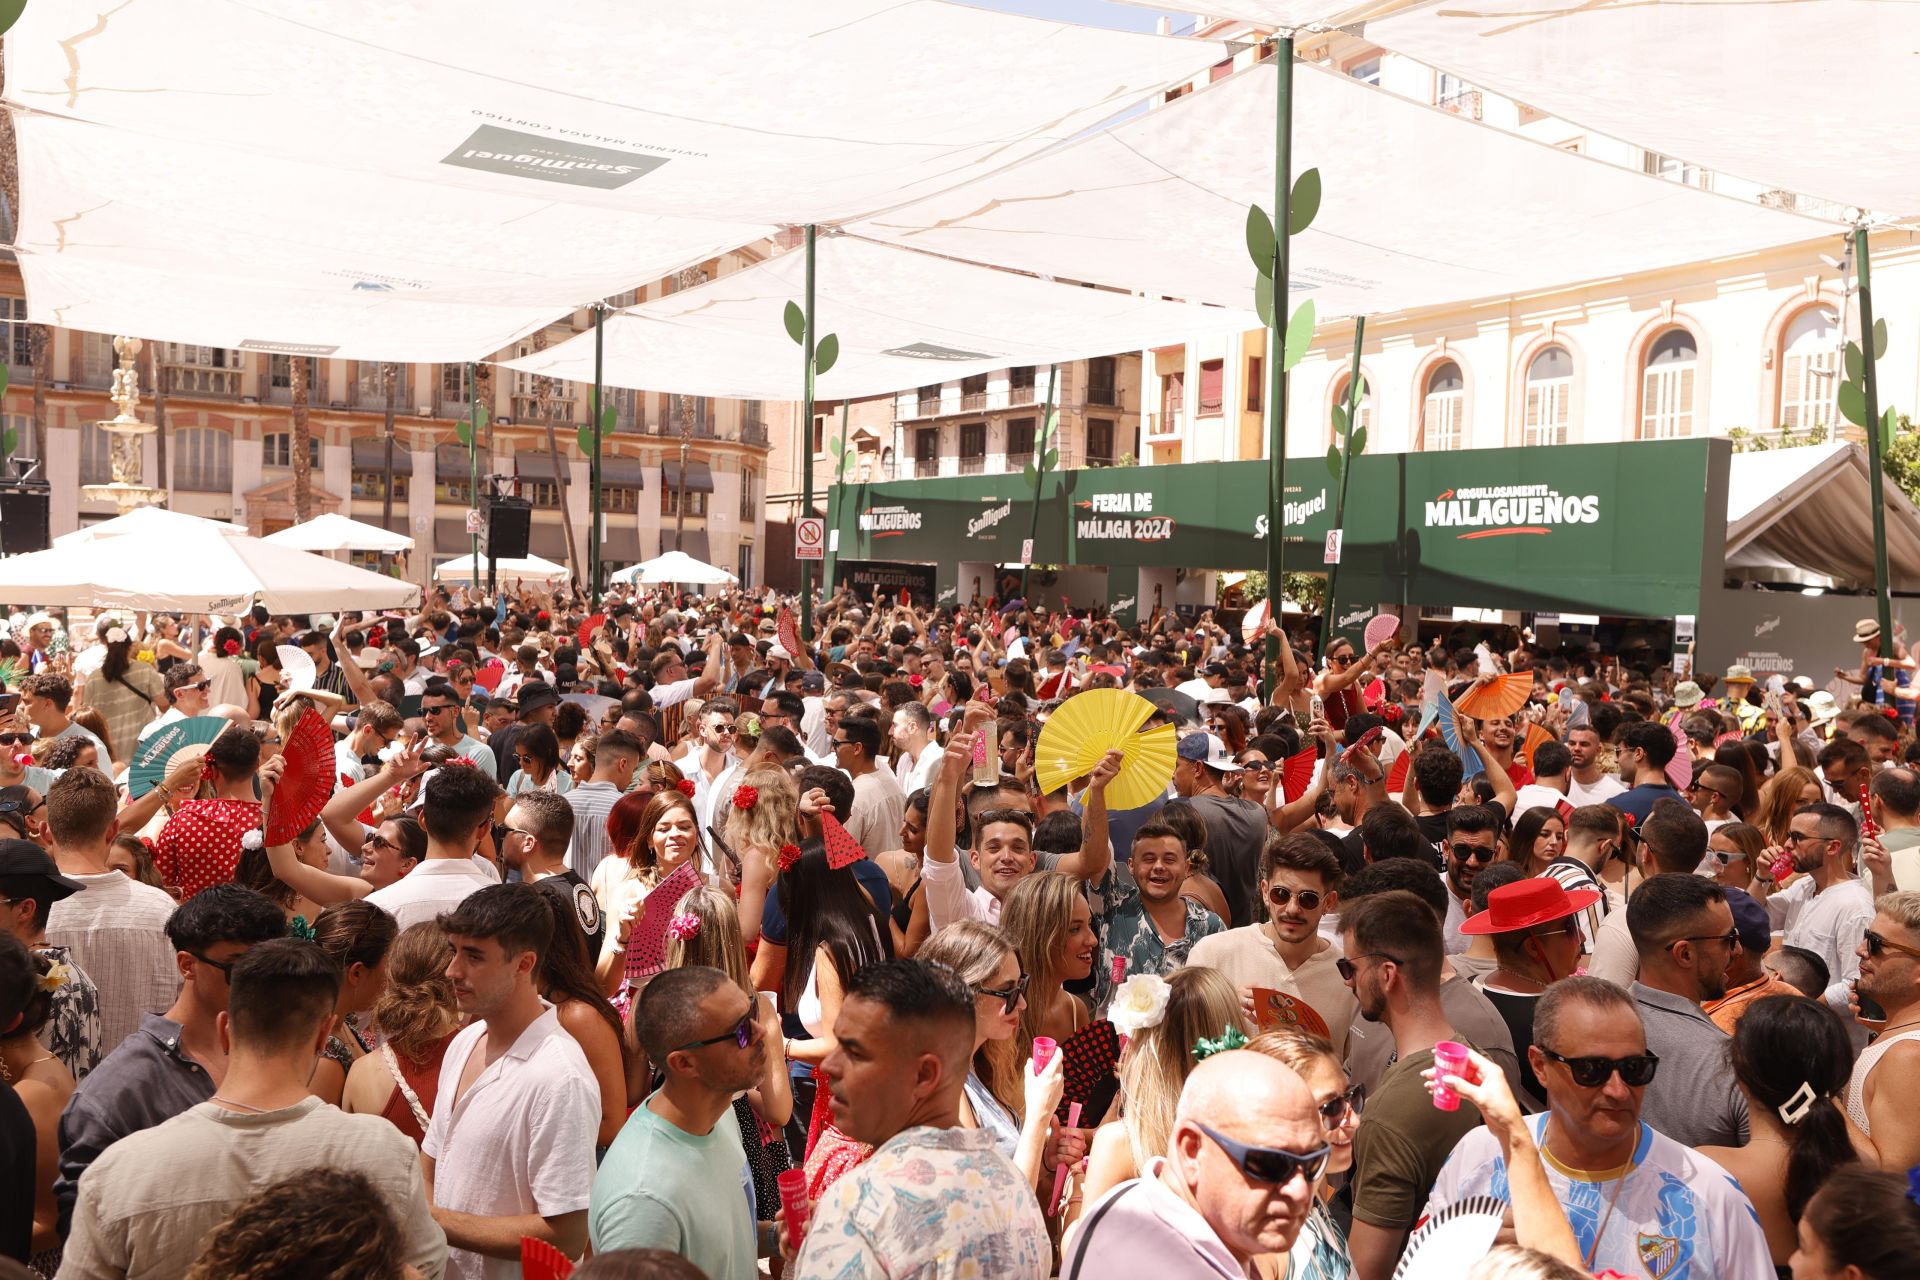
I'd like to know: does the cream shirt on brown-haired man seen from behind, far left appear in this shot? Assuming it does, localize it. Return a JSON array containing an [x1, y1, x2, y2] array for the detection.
[[46, 871, 180, 1055]]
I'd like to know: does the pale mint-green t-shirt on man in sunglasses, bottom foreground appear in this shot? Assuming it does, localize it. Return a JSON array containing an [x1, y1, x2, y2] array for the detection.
[[588, 1098, 760, 1280]]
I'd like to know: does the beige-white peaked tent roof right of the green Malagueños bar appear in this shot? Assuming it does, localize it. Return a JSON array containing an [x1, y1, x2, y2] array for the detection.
[[1726, 443, 1920, 591]]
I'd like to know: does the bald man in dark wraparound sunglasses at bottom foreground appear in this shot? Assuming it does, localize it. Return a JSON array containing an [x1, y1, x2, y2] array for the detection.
[[1060, 1050, 1329, 1280]]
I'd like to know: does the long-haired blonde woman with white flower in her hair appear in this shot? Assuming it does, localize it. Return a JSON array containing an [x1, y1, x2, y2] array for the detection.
[[1081, 965, 1248, 1205]]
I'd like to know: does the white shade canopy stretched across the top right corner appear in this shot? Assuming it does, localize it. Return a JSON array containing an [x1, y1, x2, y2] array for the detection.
[[1367, 0, 1920, 215]]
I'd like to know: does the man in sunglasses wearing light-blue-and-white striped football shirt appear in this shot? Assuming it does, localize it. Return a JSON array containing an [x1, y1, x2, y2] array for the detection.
[[1428, 977, 1774, 1280]]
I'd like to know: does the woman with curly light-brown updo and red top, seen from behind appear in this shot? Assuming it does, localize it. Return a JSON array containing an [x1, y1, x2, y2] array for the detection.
[[340, 919, 463, 1146]]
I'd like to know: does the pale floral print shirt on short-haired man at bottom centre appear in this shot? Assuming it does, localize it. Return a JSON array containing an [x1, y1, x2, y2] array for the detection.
[[795, 1126, 1054, 1280]]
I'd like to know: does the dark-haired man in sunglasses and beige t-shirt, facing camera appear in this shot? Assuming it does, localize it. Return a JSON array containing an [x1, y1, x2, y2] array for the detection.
[[1190, 831, 1356, 1059]]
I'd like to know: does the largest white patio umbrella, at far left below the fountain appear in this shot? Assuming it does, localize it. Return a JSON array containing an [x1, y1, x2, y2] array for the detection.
[[0, 509, 420, 614]]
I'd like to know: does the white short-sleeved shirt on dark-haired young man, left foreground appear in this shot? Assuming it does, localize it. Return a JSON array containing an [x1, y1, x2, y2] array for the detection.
[[426, 1005, 599, 1280]]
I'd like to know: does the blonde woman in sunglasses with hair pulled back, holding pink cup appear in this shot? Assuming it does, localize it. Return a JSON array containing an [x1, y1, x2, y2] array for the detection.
[[916, 919, 1066, 1184]]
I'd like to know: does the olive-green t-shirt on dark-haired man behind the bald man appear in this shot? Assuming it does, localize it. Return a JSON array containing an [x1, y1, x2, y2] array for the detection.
[[1351, 1050, 1480, 1230]]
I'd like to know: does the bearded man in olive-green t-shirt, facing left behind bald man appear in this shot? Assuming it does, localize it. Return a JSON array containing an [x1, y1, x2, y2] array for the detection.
[[1336, 890, 1480, 1280]]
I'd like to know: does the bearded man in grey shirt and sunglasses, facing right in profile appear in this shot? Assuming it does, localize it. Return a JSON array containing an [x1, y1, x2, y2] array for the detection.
[[1626, 871, 1747, 1148]]
